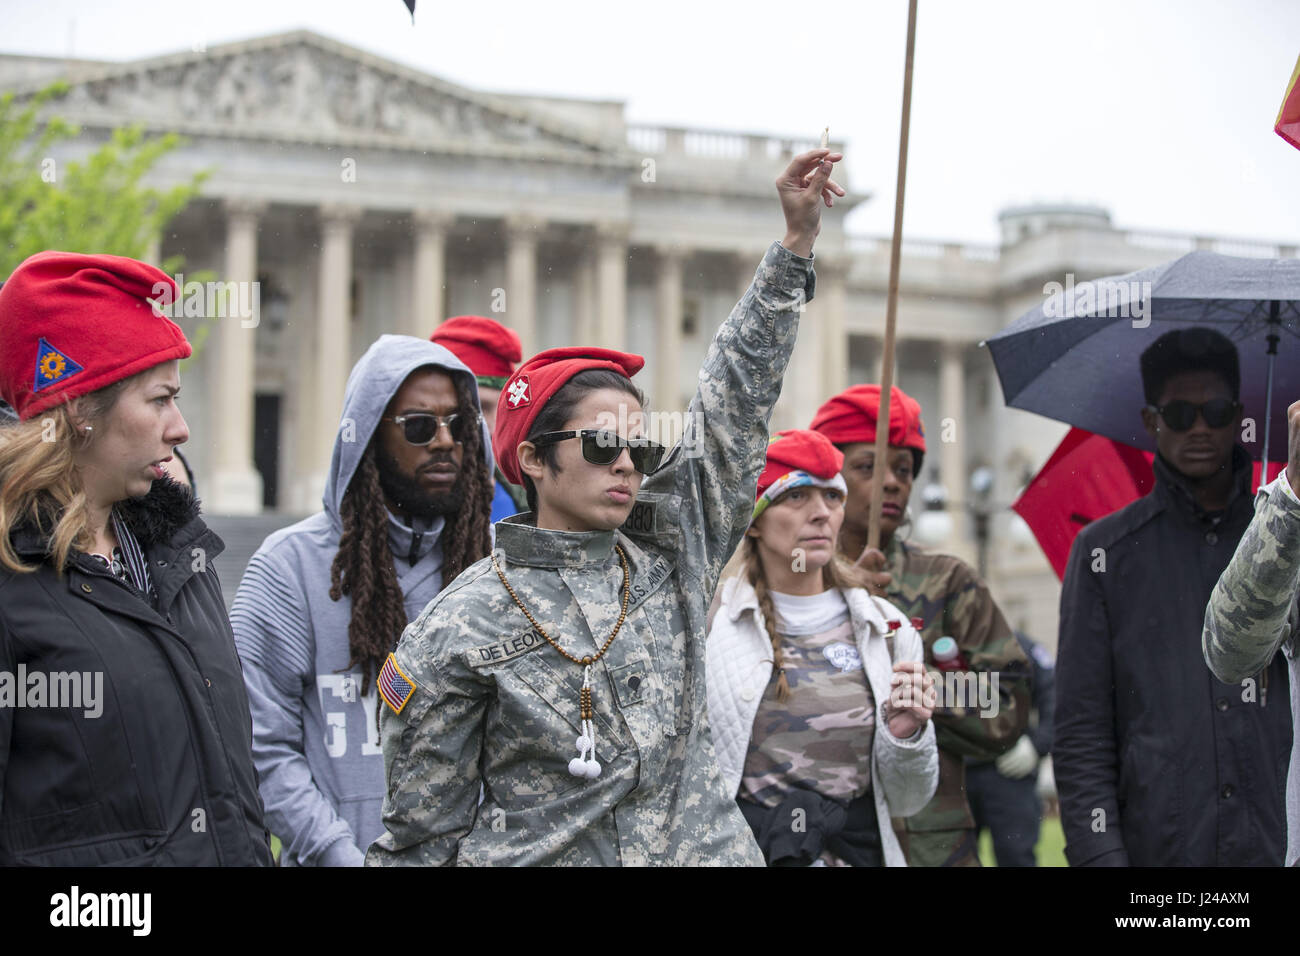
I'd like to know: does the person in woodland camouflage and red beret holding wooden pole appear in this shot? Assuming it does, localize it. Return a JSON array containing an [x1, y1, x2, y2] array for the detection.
[[810, 385, 1030, 866]]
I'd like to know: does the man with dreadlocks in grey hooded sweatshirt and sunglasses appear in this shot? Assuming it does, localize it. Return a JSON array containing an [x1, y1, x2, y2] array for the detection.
[[230, 336, 493, 866]]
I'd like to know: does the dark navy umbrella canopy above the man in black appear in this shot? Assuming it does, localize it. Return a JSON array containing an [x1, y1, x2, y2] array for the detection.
[[985, 252, 1300, 460]]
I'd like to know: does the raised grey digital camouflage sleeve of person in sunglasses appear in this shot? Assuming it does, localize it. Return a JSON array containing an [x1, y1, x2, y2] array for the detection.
[[642, 242, 815, 598]]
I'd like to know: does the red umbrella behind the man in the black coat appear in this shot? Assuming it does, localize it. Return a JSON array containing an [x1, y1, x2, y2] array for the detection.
[[1011, 428, 1286, 578]]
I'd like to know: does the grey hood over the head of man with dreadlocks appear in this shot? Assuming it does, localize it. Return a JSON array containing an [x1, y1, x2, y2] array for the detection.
[[321, 336, 493, 523]]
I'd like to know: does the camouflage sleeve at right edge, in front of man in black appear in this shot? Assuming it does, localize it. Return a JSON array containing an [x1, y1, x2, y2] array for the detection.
[[1201, 472, 1300, 684]]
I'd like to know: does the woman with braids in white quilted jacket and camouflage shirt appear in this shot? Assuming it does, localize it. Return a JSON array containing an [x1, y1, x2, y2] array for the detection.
[[706, 431, 939, 866]]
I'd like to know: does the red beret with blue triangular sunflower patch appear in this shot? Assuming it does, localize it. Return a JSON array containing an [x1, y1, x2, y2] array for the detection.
[[0, 252, 191, 420]]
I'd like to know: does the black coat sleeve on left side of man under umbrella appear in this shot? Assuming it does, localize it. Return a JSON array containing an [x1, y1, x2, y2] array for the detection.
[[1052, 529, 1128, 866]]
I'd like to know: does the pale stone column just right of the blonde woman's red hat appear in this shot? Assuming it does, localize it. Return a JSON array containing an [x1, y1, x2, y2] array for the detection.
[[204, 200, 267, 515]]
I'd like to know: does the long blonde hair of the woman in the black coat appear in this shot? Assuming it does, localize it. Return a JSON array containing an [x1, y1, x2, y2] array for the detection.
[[0, 376, 137, 576]]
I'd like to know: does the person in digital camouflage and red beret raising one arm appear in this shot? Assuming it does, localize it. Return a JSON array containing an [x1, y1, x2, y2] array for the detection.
[[367, 150, 844, 865]]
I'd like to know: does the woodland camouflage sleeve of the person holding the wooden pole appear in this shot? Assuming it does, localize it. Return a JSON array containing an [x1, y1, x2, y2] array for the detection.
[[932, 564, 1030, 760]]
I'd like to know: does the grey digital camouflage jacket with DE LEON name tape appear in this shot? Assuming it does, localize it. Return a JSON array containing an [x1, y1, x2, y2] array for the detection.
[[367, 243, 814, 865]]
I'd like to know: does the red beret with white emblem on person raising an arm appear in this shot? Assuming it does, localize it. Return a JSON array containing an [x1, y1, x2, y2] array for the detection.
[[491, 346, 646, 485]]
